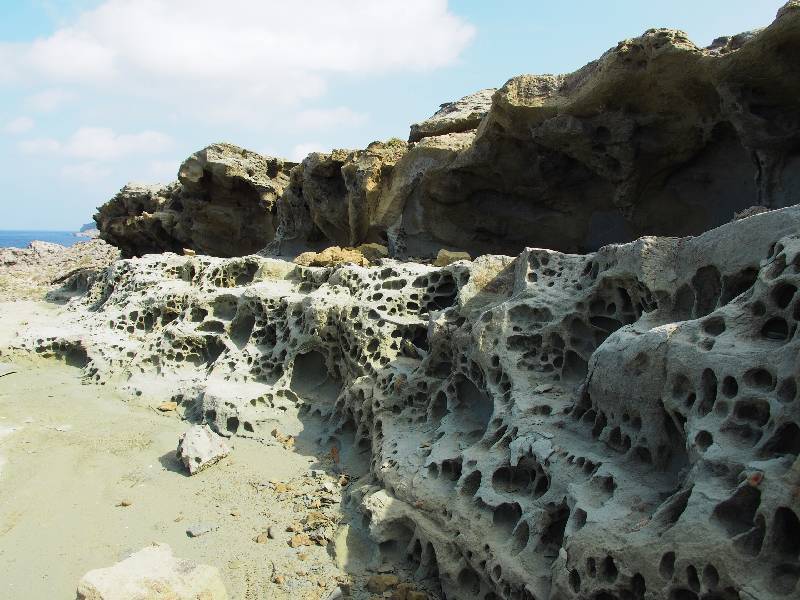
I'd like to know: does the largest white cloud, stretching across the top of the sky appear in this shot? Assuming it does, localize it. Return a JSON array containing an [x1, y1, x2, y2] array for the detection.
[[0, 0, 474, 121]]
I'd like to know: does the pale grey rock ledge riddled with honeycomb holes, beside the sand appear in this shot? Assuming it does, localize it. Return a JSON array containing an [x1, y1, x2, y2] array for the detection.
[[20, 207, 800, 600]]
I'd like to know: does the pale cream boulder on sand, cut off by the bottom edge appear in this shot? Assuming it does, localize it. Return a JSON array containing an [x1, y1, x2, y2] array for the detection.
[[78, 544, 228, 600]]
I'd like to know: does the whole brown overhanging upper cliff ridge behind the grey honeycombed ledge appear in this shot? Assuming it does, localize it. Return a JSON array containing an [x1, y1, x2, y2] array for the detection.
[[98, 0, 800, 257]]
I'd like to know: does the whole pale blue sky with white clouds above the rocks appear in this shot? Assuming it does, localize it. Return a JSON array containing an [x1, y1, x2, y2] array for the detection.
[[0, 0, 785, 230]]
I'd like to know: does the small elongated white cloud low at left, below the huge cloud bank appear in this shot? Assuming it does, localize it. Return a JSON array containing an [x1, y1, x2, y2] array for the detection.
[[19, 127, 172, 162]]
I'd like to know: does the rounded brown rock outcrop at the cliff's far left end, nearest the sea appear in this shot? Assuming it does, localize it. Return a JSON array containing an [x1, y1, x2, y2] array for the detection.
[[95, 144, 295, 256]]
